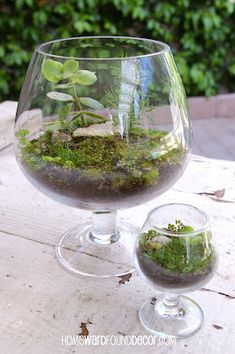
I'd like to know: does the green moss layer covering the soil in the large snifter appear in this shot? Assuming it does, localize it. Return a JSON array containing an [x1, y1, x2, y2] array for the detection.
[[18, 128, 186, 191]]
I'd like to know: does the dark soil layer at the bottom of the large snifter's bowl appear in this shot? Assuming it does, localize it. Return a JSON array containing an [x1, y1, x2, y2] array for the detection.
[[20, 154, 186, 208]]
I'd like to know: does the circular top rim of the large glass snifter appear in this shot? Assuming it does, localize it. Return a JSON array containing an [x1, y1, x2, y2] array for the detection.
[[35, 36, 171, 61]]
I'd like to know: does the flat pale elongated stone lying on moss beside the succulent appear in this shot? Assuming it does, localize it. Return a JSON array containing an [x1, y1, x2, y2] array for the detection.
[[73, 122, 119, 138]]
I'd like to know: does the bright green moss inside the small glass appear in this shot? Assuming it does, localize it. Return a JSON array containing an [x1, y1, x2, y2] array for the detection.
[[139, 224, 215, 274]]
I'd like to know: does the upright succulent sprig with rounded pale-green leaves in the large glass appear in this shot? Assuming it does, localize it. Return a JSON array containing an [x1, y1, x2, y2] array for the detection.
[[42, 59, 105, 131]]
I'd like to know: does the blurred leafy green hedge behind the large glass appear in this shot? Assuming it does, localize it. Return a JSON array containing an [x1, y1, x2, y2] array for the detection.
[[0, 0, 235, 101]]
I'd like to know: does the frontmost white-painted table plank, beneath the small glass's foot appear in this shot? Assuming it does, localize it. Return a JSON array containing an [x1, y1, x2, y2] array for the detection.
[[0, 233, 235, 354]]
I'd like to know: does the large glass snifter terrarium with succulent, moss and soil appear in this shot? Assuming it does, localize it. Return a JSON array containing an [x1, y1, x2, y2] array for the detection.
[[15, 37, 191, 277]]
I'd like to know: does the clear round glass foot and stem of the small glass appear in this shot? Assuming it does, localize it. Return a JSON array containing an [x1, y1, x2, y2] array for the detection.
[[139, 294, 204, 338]]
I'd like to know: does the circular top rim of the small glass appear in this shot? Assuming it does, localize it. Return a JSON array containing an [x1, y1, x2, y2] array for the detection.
[[147, 203, 209, 237]]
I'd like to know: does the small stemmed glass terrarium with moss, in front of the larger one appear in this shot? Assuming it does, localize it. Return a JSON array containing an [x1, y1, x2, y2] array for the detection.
[[135, 203, 218, 338]]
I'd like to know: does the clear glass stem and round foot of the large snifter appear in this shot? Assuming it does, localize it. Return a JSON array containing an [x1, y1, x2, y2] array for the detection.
[[56, 211, 138, 278]]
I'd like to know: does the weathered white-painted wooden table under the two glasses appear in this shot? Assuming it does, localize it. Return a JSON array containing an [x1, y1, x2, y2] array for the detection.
[[0, 102, 235, 354]]
